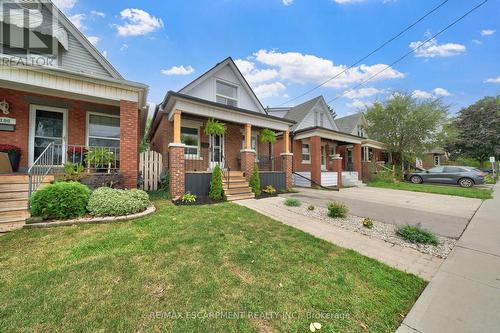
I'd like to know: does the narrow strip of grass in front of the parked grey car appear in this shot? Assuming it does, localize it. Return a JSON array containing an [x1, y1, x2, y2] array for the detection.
[[368, 181, 493, 200]]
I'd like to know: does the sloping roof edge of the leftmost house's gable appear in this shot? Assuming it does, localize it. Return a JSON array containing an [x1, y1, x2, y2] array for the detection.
[[46, 0, 123, 79]]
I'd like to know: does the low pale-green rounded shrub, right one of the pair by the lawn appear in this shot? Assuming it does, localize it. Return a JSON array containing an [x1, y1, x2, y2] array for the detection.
[[87, 187, 151, 216]]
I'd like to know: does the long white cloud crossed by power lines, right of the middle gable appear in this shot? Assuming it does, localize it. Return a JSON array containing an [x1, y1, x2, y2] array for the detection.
[[254, 50, 404, 88]]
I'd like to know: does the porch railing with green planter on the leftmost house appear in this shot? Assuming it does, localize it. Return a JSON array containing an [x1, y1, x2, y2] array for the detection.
[[28, 142, 120, 197]]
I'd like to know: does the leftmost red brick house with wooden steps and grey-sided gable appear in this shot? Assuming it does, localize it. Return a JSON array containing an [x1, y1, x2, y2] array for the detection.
[[0, 1, 148, 231]]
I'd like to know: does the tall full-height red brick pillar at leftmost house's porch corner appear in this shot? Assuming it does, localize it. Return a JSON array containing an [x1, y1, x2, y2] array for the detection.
[[120, 100, 140, 188]]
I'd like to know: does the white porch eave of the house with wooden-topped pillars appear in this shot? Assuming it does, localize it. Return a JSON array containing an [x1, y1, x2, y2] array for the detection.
[[163, 93, 293, 132]]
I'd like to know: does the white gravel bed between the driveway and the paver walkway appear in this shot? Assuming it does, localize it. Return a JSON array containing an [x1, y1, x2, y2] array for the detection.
[[283, 204, 456, 258]]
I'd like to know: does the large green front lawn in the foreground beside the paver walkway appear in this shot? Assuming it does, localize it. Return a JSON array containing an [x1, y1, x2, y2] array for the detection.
[[0, 193, 425, 332]]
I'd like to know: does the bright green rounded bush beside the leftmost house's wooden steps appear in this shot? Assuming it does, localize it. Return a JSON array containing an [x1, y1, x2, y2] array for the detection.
[[30, 182, 91, 220]]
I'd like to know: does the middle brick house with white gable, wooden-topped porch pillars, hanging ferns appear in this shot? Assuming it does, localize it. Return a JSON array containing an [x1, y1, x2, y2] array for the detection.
[[148, 58, 294, 200]]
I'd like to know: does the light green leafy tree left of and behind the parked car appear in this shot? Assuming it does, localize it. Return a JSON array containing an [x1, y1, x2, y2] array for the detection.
[[366, 93, 448, 166]]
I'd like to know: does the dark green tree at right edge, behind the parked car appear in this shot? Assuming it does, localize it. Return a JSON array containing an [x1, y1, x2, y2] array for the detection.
[[447, 96, 500, 168]]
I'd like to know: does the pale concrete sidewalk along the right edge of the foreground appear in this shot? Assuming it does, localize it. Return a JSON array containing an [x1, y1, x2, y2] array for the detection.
[[397, 184, 500, 333]]
